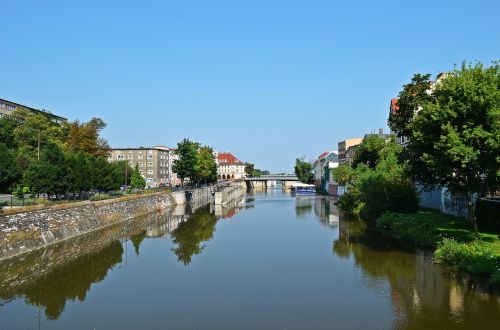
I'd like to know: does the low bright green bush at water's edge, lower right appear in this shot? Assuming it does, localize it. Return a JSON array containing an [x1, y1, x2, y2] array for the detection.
[[434, 238, 500, 281]]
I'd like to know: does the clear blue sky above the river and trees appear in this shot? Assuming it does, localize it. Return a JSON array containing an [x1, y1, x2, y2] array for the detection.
[[0, 0, 500, 171]]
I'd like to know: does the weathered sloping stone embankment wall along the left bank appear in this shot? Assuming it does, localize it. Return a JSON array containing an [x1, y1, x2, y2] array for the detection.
[[0, 193, 174, 260]]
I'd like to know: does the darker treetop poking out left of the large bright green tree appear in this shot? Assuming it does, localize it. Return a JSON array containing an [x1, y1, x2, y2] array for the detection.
[[389, 74, 432, 137]]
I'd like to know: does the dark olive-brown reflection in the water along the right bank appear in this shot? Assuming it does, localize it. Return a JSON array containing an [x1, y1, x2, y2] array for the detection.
[[333, 220, 500, 329]]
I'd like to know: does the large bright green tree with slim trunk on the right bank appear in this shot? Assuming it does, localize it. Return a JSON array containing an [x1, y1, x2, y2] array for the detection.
[[408, 62, 500, 233]]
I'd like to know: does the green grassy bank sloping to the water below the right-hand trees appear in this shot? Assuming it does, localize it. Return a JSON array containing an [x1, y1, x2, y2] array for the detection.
[[377, 209, 500, 284]]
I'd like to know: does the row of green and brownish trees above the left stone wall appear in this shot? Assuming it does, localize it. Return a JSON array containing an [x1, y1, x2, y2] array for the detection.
[[0, 110, 142, 196]]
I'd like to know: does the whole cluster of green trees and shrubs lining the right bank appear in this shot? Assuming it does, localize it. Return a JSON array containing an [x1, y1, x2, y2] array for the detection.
[[333, 62, 500, 232]]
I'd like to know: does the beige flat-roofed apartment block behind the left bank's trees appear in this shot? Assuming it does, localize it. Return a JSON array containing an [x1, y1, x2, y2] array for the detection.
[[108, 147, 170, 187]]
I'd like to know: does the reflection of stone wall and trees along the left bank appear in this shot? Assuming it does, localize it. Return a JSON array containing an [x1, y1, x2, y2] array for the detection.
[[0, 197, 243, 320]]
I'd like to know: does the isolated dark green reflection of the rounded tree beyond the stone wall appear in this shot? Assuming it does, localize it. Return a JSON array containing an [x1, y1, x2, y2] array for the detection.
[[171, 207, 217, 266]]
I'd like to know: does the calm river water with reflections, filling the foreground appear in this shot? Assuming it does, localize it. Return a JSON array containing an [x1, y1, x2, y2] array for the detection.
[[0, 189, 500, 330]]
